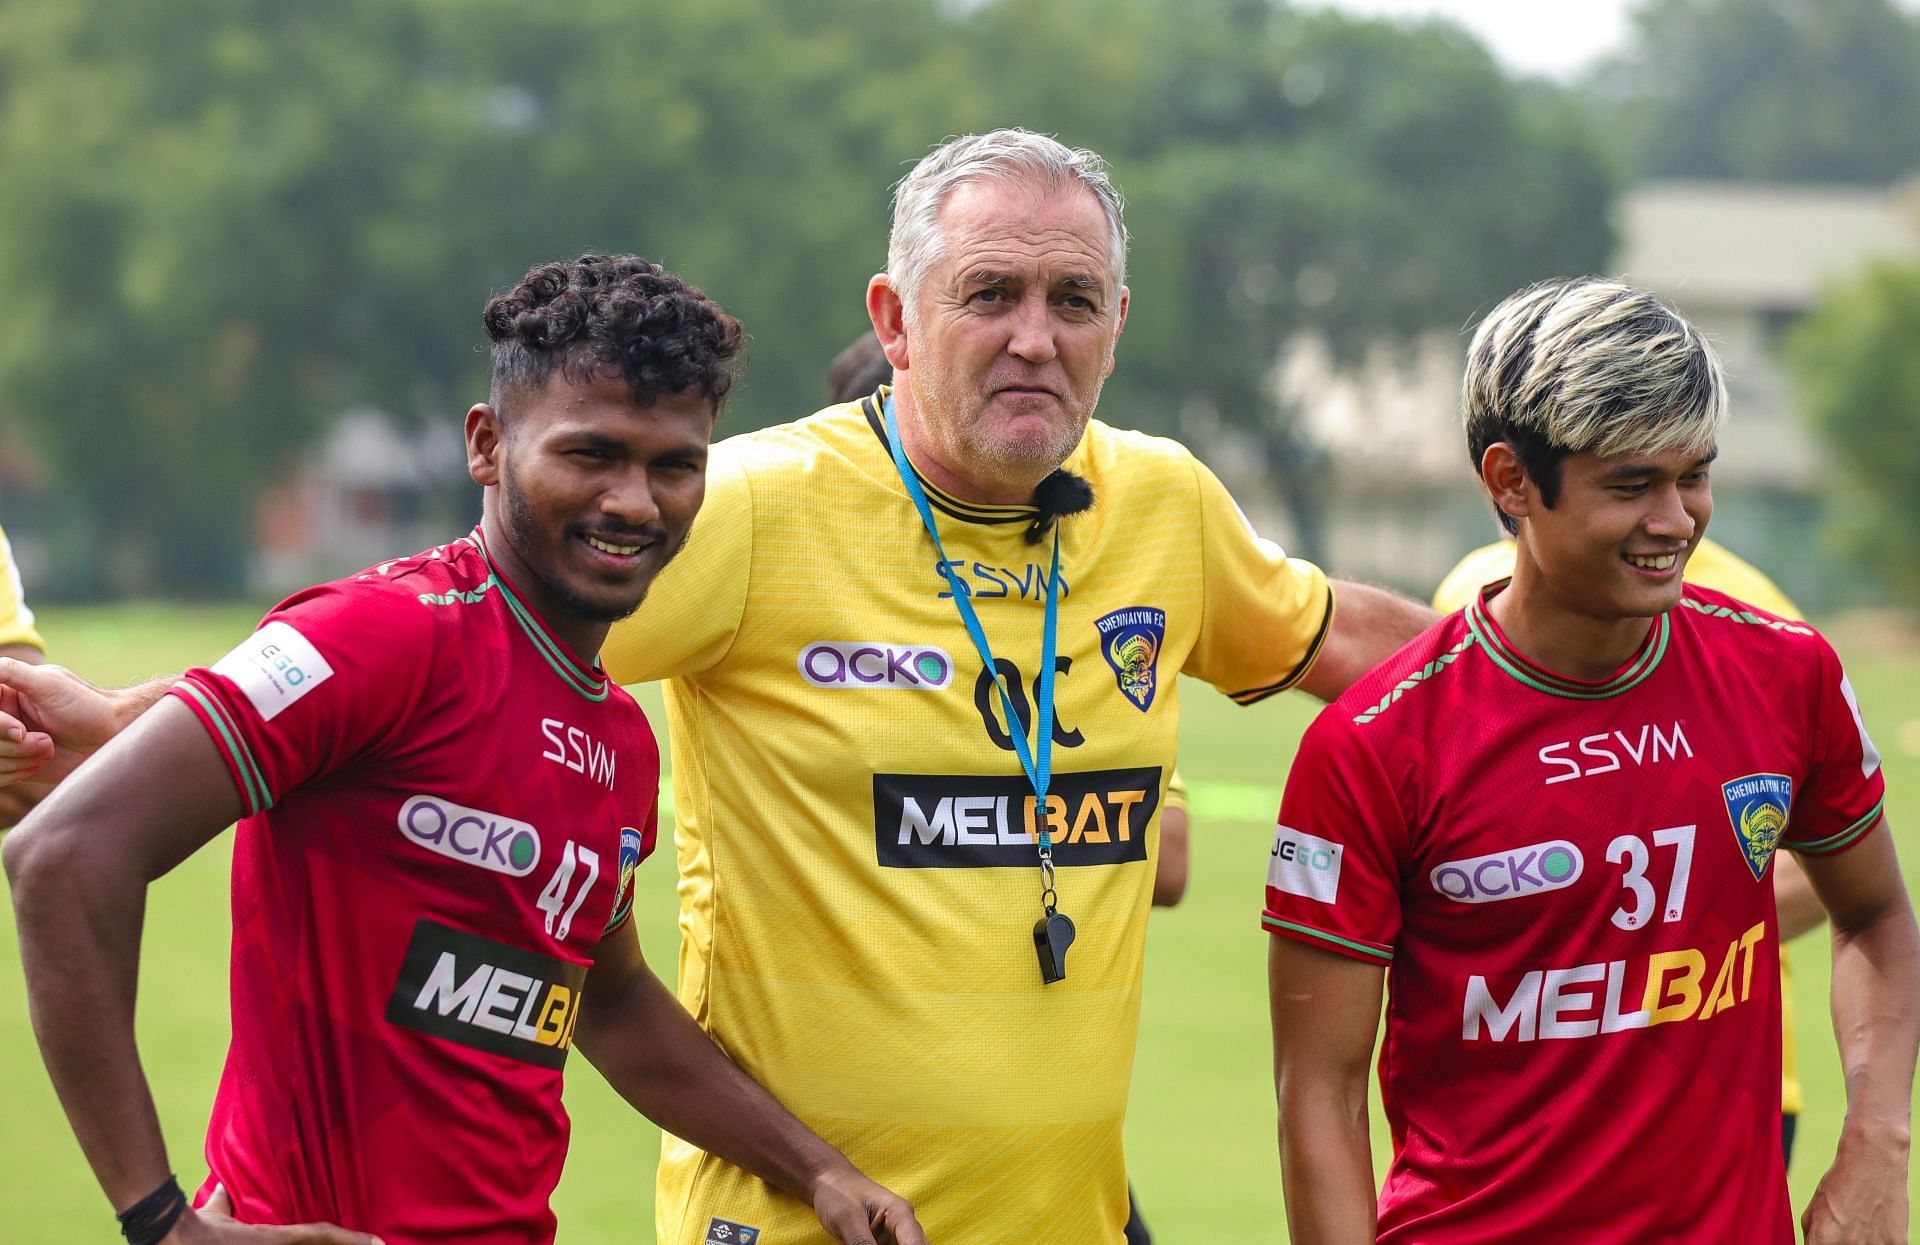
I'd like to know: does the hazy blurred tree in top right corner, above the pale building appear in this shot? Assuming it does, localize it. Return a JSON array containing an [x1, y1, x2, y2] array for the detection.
[[1594, 0, 1920, 183]]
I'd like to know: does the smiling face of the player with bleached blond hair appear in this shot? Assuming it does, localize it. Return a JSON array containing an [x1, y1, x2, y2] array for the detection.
[[1496, 450, 1715, 621]]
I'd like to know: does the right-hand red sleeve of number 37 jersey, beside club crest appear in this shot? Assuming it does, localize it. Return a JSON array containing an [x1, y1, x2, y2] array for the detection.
[[1780, 636, 1887, 855]]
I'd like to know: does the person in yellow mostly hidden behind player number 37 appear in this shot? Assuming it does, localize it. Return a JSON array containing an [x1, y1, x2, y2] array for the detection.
[[1434, 536, 1826, 1160]]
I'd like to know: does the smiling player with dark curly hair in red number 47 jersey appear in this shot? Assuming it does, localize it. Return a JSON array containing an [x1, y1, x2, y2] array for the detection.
[[0, 256, 924, 1245]]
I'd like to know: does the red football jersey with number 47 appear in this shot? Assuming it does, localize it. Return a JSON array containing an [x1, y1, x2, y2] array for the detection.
[[173, 532, 660, 1245]]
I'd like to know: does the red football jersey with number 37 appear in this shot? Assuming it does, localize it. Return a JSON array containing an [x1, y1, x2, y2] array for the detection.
[[1265, 586, 1884, 1245]]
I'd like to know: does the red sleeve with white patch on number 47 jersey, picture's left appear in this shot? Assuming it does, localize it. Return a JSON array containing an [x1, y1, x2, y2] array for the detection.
[[171, 584, 434, 817]]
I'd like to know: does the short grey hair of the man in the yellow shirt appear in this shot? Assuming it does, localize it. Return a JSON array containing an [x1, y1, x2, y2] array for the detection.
[[887, 129, 1127, 309]]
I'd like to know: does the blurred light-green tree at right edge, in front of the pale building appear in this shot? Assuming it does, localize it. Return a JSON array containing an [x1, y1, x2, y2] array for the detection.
[[1788, 263, 1920, 603]]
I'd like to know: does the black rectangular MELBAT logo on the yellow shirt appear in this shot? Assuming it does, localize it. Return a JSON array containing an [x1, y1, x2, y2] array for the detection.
[[874, 767, 1160, 868]]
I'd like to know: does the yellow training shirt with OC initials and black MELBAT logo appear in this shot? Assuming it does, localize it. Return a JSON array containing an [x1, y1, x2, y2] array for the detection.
[[603, 390, 1332, 1245]]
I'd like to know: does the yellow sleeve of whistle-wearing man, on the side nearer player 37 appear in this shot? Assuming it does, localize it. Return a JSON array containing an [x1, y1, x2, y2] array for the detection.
[[1185, 461, 1332, 705]]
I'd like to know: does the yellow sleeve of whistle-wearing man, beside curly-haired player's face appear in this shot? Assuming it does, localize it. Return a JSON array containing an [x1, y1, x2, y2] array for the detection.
[[601, 446, 755, 684]]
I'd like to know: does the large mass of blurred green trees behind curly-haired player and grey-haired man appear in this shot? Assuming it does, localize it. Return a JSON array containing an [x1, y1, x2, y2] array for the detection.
[[0, 0, 1611, 592]]
